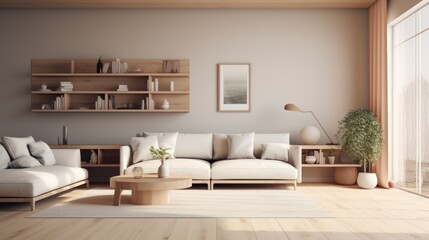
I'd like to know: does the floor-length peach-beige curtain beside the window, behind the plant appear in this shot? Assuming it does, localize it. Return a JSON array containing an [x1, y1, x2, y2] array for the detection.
[[369, 0, 389, 188]]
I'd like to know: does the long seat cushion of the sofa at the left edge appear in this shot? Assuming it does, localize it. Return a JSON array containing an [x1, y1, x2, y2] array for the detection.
[[0, 165, 88, 197]]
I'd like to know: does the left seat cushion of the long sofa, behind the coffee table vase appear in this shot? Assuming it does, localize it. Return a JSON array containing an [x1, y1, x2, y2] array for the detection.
[[125, 158, 210, 180]]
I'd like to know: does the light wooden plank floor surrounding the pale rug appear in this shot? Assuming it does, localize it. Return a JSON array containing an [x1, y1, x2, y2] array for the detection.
[[0, 184, 429, 240]]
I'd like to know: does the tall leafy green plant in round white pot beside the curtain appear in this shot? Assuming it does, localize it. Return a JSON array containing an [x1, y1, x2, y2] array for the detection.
[[336, 108, 383, 189]]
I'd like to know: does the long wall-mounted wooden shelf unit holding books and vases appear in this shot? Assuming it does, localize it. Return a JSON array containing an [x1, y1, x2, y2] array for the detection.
[[31, 59, 190, 112]]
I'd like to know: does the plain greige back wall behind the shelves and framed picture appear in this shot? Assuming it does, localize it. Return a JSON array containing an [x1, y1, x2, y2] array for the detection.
[[0, 9, 368, 144]]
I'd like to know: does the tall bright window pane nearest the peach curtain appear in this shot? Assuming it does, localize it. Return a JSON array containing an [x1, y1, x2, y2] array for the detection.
[[393, 38, 417, 191]]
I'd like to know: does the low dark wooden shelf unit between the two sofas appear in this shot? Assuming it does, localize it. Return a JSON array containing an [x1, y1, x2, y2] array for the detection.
[[49, 144, 121, 182]]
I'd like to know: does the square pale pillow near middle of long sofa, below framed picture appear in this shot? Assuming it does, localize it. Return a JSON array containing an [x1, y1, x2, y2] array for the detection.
[[227, 132, 255, 159]]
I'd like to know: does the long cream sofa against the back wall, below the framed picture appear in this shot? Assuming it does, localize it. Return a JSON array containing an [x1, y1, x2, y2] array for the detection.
[[120, 133, 301, 189]]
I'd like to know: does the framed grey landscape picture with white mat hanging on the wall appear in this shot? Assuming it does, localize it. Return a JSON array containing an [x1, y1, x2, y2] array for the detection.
[[217, 63, 250, 112]]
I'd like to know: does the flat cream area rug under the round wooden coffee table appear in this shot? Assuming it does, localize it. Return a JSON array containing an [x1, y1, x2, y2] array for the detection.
[[30, 189, 334, 218]]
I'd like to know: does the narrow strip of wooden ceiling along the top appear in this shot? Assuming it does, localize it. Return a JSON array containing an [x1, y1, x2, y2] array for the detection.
[[0, 0, 376, 8]]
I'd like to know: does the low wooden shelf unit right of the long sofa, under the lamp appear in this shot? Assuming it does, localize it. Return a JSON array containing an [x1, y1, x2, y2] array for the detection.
[[300, 145, 361, 185]]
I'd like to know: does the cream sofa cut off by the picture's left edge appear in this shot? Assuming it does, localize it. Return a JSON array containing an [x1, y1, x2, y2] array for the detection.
[[0, 149, 88, 211]]
